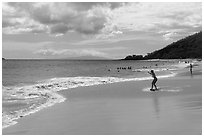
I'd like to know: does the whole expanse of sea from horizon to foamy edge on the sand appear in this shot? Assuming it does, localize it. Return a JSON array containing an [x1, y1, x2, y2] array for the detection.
[[2, 60, 190, 128]]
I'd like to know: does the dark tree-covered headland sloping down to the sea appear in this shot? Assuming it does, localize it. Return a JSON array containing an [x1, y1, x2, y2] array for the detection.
[[123, 31, 202, 60]]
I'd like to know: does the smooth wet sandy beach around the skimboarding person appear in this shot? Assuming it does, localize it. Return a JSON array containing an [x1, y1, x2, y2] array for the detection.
[[2, 71, 202, 135]]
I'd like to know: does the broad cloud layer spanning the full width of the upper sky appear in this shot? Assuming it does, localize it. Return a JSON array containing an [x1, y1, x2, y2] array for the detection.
[[2, 2, 202, 40]]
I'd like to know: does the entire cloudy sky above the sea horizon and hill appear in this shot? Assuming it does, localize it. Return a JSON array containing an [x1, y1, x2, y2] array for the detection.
[[2, 2, 202, 59]]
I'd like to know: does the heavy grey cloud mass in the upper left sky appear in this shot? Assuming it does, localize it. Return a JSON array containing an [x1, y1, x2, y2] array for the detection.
[[3, 2, 124, 35]]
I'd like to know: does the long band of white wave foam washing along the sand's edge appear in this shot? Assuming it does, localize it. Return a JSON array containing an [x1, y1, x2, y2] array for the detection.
[[3, 73, 176, 128]]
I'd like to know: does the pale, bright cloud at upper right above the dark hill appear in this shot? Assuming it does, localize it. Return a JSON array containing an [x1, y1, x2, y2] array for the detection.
[[113, 2, 202, 39]]
